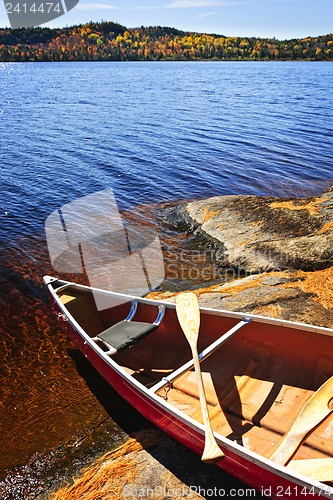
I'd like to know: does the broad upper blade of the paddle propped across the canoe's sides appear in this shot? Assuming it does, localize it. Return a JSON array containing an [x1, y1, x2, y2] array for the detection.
[[176, 292, 200, 345]]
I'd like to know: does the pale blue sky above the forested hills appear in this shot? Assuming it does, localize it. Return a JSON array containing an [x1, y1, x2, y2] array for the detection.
[[0, 0, 333, 39]]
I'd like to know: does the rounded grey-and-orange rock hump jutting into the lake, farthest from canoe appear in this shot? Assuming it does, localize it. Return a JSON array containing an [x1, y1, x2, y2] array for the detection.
[[181, 189, 333, 273]]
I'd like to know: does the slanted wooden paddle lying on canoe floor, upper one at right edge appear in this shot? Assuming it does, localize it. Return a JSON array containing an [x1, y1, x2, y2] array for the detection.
[[271, 377, 333, 465]]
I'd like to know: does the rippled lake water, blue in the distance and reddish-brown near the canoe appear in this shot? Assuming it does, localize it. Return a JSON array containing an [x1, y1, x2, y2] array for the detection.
[[0, 62, 333, 499]]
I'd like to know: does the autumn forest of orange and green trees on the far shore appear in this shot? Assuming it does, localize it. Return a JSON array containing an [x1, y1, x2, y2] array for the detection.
[[0, 22, 333, 62]]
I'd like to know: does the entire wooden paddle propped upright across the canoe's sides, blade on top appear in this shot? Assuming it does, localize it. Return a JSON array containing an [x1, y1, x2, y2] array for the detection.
[[176, 292, 224, 462]]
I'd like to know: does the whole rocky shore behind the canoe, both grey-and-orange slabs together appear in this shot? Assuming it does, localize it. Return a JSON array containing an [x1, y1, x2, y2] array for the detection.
[[150, 188, 333, 327]]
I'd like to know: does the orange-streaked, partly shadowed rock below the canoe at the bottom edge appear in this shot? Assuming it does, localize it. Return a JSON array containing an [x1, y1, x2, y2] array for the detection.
[[46, 429, 263, 500]]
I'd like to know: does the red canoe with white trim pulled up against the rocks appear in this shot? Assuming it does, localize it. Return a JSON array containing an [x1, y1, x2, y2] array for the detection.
[[44, 276, 333, 499]]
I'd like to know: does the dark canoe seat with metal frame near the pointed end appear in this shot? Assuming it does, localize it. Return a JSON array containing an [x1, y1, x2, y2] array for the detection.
[[93, 300, 165, 354]]
